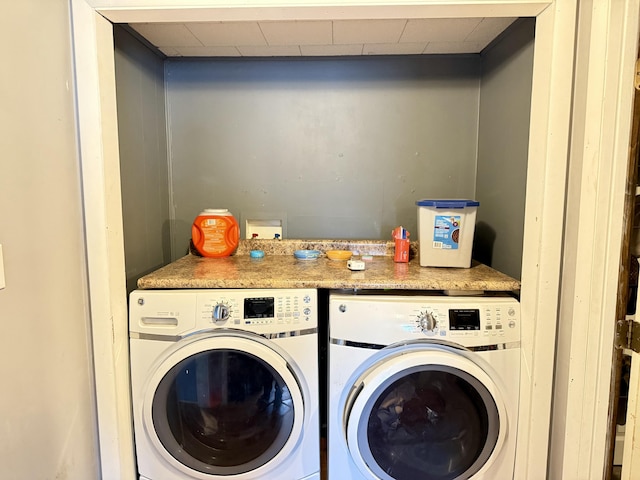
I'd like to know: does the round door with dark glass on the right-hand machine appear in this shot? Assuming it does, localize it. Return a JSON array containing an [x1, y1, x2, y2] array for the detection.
[[344, 345, 507, 480]]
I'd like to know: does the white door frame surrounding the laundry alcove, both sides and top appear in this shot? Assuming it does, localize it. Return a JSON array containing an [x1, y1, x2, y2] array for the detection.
[[70, 0, 588, 480]]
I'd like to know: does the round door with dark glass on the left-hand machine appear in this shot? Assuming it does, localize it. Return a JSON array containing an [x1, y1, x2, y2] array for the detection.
[[143, 332, 304, 479]]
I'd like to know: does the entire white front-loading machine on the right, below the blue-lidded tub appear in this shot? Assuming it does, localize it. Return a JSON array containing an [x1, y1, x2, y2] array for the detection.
[[327, 294, 521, 480]]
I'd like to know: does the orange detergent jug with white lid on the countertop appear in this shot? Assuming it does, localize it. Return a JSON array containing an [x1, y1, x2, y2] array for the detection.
[[191, 208, 240, 257]]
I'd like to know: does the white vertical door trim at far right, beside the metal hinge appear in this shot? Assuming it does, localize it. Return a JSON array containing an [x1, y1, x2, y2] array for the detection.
[[550, 0, 640, 479]]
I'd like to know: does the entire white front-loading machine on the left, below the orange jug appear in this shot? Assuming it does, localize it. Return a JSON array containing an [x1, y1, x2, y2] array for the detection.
[[129, 289, 320, 480]]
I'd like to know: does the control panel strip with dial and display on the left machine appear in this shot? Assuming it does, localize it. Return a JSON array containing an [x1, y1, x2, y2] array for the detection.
[[129, 289, 318, 336]]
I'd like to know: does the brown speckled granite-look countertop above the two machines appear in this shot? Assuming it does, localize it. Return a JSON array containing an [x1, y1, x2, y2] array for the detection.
[[138, 240, 520, 291]]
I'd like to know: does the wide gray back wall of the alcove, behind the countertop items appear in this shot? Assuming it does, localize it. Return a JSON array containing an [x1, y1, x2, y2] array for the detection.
[[166, 55, 480, 257]]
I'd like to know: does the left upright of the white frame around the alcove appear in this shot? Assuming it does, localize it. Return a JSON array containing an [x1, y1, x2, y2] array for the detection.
[[71, 0, 137, 480]]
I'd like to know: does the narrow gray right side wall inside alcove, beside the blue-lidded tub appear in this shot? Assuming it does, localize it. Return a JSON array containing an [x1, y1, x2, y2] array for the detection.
[[474, 19, 535, 278]]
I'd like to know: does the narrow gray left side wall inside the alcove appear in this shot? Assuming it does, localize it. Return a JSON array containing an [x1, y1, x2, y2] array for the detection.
[[114, 30, 171, 291]]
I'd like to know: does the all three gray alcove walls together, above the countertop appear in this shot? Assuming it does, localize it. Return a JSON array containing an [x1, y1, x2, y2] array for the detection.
[[114, 18, 535, 291]]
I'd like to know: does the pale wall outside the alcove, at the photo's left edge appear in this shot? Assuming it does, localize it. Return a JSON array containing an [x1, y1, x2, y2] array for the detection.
[[0, 0, 99, 480]]
